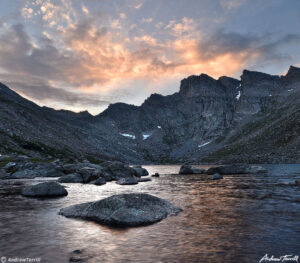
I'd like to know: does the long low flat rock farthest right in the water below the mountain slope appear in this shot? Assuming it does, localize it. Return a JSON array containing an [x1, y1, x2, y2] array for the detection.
[[206, 164, 267, 174]]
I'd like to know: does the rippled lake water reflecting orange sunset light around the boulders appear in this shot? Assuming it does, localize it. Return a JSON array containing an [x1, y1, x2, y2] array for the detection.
[[0, 165, 300, 263]]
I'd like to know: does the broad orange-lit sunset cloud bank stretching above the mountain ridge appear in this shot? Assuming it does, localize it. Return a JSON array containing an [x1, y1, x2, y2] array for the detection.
[[0, 0, 300, 114]]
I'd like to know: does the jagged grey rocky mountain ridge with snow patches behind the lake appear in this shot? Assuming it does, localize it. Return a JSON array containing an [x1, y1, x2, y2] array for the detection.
[[0, 66, 300, 163]]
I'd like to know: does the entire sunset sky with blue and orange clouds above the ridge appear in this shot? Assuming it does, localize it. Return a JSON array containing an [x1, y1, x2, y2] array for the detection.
[[0, 0, 300, 114]]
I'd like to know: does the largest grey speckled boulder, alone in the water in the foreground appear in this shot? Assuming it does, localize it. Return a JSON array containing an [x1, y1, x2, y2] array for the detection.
[[59, 194, 182, 227]]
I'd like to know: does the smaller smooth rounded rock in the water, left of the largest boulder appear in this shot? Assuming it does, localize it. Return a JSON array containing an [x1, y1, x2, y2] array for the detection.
[[21, 182, 68, 197]]
